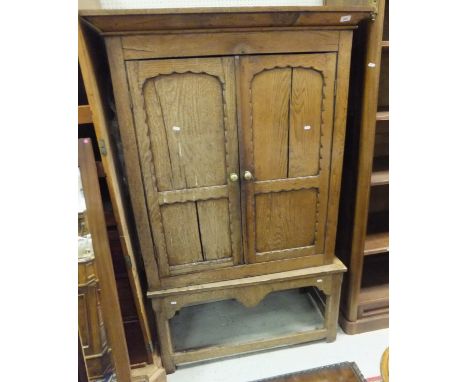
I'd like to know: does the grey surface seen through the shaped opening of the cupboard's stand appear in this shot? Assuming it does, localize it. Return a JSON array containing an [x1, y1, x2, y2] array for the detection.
[[170, 290, 324, 351]]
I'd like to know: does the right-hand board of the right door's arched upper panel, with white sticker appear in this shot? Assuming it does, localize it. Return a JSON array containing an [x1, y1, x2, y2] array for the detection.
[[287, 68, 323, 177]]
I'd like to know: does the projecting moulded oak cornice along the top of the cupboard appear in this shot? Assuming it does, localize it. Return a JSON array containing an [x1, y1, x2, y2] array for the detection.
[[79, 1, 374, 35]]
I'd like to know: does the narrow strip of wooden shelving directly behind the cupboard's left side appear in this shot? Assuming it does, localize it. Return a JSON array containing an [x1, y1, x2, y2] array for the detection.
[[78, 25, 166, 382]]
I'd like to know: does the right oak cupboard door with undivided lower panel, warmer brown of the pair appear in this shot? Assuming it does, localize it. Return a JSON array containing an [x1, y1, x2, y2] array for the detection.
[[240, 53, 336, 263]]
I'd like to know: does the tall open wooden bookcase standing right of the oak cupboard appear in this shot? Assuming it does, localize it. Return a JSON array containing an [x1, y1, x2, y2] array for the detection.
[[337, 0, 389, 334]]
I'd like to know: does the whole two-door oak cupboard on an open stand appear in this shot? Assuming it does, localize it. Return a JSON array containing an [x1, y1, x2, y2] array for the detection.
[[81, 4, 373, 372]]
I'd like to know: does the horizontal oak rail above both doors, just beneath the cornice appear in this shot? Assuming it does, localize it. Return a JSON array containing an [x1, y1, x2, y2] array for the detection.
[[122, 31, 339, 60]]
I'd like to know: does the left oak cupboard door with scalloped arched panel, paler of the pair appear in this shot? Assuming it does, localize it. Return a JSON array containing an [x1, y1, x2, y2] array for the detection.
[[126, 58, 241, 277]]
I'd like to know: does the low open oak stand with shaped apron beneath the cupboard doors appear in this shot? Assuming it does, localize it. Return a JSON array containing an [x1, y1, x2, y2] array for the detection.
[[148, 259, 346, 373]]
